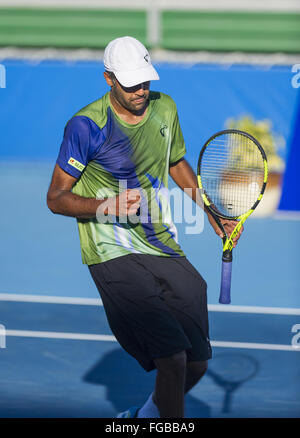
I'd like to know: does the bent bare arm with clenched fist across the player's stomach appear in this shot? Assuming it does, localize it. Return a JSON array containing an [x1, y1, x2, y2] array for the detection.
[[47, 164, 140, 219]]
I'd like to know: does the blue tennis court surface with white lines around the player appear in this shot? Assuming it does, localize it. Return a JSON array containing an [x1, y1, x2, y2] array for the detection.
[[0, 160, 300, 418]]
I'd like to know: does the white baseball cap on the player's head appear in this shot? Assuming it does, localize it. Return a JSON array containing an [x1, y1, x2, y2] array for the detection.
[[104, 36, 159, 87]]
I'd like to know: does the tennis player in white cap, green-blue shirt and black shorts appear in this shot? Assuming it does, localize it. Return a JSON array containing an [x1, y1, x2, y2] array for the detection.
[[47, 36, 244, 418]]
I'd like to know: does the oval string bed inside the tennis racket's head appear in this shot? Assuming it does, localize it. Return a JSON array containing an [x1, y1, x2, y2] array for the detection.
[[200, 133, 264, 217]]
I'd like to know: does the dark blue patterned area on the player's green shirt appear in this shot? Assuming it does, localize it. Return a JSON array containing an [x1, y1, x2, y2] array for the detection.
[[57, 107, 179, 256]]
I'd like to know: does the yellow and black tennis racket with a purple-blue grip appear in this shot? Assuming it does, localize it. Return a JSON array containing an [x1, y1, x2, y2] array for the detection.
[[197, 129, 268, 304]]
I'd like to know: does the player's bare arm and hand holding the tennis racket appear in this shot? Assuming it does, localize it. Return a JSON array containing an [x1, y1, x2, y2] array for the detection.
[[169, 158, 243, 246]]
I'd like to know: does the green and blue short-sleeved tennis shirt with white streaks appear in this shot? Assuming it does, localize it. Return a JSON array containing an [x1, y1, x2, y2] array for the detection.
[[57, 91, 186, 265]]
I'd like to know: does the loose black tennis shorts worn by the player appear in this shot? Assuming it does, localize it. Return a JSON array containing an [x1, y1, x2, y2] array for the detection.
[[89, 254, 211, 371]]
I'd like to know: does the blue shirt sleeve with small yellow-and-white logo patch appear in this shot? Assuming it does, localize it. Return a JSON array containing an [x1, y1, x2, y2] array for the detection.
[[56, 116, 90, 178]]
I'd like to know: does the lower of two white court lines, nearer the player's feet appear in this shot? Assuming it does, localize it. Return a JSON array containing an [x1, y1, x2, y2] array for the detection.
[[5, 330, 300, 352]]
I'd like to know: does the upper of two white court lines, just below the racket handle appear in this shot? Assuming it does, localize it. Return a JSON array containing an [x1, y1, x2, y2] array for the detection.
[[0, 293, 300, 315]]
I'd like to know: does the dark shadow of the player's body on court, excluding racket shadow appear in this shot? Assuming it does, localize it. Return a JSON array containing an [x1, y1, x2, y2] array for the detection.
[[83, 348, 210, 418]]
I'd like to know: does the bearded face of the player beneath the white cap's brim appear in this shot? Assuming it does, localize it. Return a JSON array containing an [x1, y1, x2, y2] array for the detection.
[[105, 74, 150, 113]]
